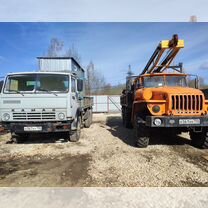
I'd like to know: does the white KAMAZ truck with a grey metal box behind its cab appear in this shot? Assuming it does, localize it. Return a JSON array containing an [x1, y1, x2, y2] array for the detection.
[[0, 57, 93, 143]]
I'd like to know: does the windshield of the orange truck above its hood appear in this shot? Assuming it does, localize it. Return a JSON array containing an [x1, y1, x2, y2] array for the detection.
[[144, 76, 187, 88]]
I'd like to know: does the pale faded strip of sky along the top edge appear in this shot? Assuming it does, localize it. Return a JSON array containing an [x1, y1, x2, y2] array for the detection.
[[0, 0, 208, 22]]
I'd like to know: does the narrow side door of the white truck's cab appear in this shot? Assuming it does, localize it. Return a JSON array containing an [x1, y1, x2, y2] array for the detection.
[[70, 77, 79, 129]]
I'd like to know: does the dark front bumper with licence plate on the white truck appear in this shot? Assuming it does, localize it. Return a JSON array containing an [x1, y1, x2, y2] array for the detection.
[[3, 122, 71, 133]]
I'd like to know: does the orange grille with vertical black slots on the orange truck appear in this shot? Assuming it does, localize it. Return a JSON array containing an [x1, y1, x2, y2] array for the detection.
[[171, 95, 203, 114]]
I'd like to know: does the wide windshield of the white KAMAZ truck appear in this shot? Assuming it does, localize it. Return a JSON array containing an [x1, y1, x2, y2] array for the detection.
[[4, 74, 69, 93]]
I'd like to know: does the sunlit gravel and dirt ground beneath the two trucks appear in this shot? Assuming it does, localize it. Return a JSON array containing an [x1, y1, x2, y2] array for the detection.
[[0, 114, 208, 187]]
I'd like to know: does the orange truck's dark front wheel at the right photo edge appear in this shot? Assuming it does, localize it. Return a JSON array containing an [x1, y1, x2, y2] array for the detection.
[[189, 128, 208, 149]]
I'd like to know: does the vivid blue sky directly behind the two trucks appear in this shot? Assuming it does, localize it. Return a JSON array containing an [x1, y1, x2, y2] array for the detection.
[[0, 22, 208, 84]]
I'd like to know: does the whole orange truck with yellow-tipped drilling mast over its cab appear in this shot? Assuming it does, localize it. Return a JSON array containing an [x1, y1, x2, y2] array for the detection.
[[120, 35, 208, 148]]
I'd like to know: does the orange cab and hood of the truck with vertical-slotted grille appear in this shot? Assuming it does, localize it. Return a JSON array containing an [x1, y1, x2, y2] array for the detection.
[[134, 73, 207, 116]]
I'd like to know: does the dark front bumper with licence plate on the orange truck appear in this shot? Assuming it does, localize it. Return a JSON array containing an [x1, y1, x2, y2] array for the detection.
[[145, 116, 208, 128]]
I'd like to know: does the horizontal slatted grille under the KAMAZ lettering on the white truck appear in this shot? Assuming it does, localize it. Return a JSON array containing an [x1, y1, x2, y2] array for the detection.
[[13, 112, 56, 120]]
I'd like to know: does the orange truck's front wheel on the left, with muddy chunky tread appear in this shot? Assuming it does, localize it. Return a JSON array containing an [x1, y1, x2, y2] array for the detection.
[[134, 119, 150, 148]]
